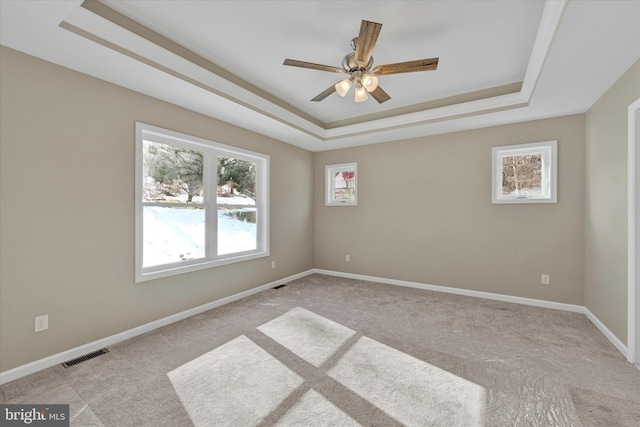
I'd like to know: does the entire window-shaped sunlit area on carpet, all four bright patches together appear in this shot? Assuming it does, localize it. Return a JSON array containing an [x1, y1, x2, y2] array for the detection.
[[167, 307, 486, 427]]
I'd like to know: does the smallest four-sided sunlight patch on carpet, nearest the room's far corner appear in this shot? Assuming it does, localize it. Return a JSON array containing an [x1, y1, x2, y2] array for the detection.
[[258, 307, 356, 368]]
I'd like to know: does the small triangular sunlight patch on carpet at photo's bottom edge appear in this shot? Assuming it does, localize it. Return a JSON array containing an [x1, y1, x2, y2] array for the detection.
[[276, 389, 362, 427]]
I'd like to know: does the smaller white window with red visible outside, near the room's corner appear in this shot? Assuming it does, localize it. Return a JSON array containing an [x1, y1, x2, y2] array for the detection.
[[324, 162, 358, 206]]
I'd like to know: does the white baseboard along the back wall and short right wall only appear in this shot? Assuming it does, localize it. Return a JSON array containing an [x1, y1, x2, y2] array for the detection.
[[313, 268, 628, 359]]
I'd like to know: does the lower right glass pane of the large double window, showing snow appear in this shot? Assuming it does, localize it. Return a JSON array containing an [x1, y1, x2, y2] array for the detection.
[[218, 206, 258, 255]]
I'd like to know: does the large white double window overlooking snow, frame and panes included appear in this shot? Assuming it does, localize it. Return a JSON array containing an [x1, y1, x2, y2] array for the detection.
[[136, 123, 269, 282]]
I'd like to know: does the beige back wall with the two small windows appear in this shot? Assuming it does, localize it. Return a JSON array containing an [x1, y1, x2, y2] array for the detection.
[[314, 115, 584, 305]]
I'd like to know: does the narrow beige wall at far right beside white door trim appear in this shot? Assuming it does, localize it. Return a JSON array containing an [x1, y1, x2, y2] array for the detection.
[[585, 61, 640, 343]]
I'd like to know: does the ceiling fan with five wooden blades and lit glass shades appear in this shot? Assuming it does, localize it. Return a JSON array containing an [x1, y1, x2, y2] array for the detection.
[[283, 20, 439, 104]]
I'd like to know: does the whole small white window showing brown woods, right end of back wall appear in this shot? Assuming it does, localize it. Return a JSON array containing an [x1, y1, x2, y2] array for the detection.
[[491, 141, 558, 203]]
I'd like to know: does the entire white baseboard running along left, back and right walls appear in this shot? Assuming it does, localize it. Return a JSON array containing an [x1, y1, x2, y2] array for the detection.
[[0, 268, 627, 385]]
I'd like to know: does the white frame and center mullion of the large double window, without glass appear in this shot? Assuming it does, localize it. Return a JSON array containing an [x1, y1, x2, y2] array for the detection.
[[135, 122, 270, 283]]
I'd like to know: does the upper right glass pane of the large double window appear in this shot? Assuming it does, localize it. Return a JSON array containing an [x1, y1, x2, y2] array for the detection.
[[217, 156, 256, 205]]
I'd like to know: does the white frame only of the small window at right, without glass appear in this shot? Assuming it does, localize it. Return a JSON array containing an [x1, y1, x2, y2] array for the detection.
[[491, 140, 558, 204]]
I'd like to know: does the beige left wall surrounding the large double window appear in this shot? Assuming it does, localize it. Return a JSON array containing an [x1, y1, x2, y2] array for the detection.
[[0, 47, 313, 371]]
